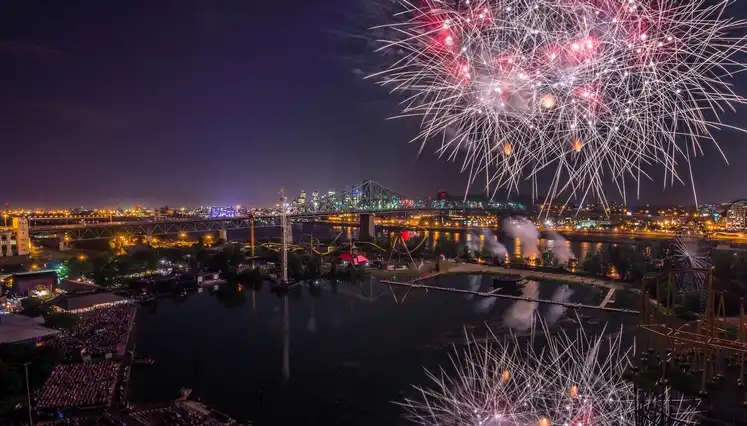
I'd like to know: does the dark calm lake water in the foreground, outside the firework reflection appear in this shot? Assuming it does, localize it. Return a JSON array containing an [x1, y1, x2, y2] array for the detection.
[[132, 276, 635, 425]]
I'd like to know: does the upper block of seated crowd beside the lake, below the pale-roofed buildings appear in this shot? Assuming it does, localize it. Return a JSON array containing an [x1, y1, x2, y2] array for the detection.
[[57, 305, 136, 360]]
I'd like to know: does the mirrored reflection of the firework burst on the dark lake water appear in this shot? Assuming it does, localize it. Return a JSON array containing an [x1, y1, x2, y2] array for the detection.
[[401, 323, 697, 426]]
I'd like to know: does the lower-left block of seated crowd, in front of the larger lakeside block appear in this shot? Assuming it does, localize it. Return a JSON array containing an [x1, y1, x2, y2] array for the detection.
[[34, 362, 120, 410]]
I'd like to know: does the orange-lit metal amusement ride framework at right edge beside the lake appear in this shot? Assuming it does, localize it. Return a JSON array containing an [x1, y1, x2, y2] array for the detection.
[[635, 267, 747, 424]]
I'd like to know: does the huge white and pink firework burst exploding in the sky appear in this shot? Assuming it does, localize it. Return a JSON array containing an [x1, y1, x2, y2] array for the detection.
[[370, 0, 747, 207]]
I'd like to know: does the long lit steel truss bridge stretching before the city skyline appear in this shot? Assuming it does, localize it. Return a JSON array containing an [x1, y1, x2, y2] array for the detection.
[[30, 180, 524, 241]]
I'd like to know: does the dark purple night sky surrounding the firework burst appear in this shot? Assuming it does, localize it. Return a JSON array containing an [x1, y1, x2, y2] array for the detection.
[[0, 0, 747, 207]]
